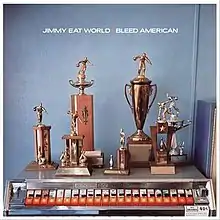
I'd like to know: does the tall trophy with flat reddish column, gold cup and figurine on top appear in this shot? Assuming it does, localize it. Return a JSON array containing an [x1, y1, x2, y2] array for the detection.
[[69, 57, 94, 151]]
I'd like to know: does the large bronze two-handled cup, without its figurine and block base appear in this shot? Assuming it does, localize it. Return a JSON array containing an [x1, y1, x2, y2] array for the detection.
[[125, 76, 157, 141]]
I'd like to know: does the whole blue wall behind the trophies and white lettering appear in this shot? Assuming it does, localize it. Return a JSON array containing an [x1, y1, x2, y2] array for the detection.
[[4, 5, 215, 182]]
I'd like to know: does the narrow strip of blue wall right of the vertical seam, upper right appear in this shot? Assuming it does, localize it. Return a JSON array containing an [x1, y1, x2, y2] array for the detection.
[[196, 5, 216, 101]]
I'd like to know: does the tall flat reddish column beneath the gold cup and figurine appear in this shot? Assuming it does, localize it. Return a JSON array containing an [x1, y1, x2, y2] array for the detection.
[[71, 94, 94, 151]]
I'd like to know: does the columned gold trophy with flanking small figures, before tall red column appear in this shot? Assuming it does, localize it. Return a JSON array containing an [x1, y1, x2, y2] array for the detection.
[[55, 111, 92, 177]]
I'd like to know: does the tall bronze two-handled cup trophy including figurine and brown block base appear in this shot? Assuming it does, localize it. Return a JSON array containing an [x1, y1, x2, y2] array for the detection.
[[125, 53, 157, 167]]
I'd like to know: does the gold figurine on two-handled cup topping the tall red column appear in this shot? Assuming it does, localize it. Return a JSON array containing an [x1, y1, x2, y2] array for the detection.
[[69, 57, 94, 95]]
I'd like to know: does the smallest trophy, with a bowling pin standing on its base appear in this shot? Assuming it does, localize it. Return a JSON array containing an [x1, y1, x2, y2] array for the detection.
[[104, 129, 130, 175]]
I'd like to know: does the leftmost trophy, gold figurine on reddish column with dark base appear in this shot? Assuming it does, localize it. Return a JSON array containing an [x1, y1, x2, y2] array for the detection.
[[25, 103, 58, 171]]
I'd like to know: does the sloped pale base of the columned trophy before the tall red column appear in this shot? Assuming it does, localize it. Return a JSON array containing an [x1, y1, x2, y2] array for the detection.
[[55, 166, 91, 177]]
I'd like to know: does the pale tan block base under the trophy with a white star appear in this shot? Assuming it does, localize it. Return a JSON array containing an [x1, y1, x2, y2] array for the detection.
[[150, 163, 176, 175]]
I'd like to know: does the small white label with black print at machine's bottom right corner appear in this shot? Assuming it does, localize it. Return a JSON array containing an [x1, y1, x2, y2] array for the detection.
[[185, 205, 209, 217]]
